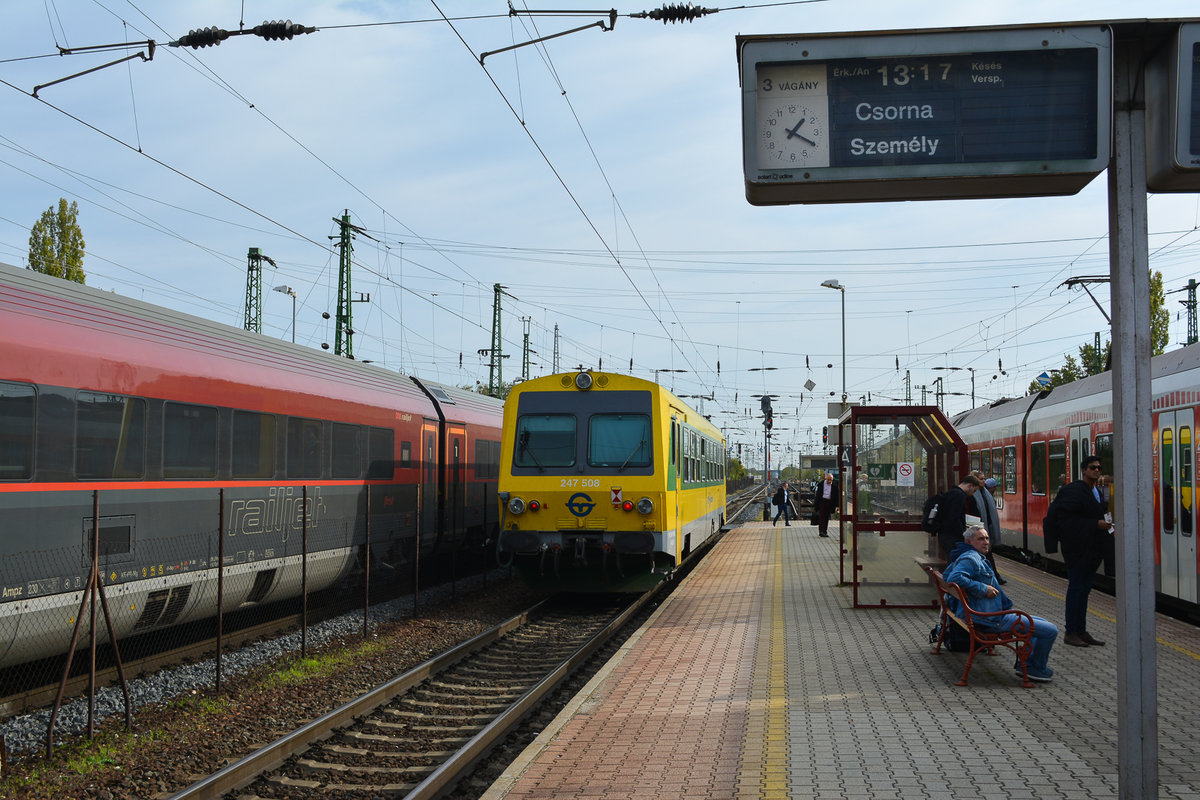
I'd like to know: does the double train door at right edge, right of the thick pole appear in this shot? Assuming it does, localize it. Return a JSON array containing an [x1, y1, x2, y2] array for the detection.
[[1157, 409, 1196, 603]]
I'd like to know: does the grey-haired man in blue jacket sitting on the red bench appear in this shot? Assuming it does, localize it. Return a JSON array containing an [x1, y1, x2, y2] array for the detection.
[[942, 525, 1058, 682]]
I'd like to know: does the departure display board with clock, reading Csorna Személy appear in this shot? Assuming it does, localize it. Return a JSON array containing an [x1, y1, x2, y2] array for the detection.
[[739, 25, 1111, 204]]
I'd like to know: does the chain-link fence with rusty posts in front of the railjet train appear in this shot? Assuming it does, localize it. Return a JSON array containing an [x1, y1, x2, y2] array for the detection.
[[0, 486, 496, 753]]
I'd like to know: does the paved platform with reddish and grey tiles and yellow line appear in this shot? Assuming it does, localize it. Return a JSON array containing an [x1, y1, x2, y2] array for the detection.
[[484, 522, 1200, 800]]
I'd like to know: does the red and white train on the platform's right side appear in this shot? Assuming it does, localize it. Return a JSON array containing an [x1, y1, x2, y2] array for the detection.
[[954, 344, 1200, 608]]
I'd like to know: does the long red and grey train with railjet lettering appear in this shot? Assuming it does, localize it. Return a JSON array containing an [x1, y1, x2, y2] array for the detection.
[[0, 265, 502, 666]]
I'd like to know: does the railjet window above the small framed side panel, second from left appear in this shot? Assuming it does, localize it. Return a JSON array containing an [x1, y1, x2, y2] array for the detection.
[[76, 392, 146, 477]]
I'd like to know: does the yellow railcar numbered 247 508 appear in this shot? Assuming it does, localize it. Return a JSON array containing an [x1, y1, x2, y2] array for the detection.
[[498, 372, 725, 591]]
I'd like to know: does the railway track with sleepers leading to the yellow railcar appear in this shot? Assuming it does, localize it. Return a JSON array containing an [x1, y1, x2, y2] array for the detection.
[[172, 591, 658, 800]]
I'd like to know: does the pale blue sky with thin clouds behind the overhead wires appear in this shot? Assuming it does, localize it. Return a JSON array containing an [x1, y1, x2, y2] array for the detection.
[[0, 0, 1200, 470]]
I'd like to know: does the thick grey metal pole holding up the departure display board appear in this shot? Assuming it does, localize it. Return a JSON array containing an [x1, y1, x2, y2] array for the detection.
[[1109, 34, 1158, 800]]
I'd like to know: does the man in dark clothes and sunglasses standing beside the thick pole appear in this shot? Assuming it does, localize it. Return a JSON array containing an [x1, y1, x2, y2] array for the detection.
[[1046, 456, 1112, 648]]
